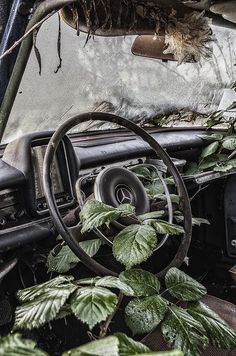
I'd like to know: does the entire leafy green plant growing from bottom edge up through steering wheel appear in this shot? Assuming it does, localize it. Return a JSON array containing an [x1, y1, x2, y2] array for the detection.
[[10, 200, 236, 356]]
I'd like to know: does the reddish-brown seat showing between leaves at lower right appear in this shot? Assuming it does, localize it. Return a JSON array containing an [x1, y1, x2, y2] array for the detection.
[[142, 295, 236, 356]]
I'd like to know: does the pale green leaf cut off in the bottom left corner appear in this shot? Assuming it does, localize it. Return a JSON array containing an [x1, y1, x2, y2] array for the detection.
[[0, 334, 47, 356]]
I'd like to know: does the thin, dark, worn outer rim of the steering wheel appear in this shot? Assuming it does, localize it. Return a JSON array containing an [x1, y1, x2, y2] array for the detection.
[[43, 112, 192, 277]]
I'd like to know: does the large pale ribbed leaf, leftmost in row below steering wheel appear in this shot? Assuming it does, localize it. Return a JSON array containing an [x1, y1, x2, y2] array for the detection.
[[14, 276, 77, 329]]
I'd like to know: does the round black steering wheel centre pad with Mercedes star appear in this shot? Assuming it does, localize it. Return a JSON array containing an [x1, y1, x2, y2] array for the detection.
[[94, 167, 150, 215]]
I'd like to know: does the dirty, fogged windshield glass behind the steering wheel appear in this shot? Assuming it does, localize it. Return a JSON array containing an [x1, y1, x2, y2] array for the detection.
[[3, 16, 236, 142]]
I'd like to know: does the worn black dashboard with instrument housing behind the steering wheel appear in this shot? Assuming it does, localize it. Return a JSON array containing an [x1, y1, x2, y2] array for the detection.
[[0, 128, 230, 252]]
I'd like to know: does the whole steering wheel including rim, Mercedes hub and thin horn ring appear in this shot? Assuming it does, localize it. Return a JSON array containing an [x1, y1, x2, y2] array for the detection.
[[43, 112, 192, 277]]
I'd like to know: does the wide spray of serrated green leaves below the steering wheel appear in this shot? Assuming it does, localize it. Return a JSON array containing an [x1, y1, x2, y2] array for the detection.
[[14, 268, 236, 356]]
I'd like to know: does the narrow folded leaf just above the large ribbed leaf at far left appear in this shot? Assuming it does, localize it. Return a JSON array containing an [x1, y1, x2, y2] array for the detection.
[[17, 276, 74, 302]]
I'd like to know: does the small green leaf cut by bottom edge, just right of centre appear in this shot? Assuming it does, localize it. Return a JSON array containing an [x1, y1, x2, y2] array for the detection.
[[114, 333, 150, 356]]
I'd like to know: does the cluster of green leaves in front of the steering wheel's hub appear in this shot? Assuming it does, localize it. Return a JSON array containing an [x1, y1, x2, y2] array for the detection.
[[80, 200, 184, 268]]
